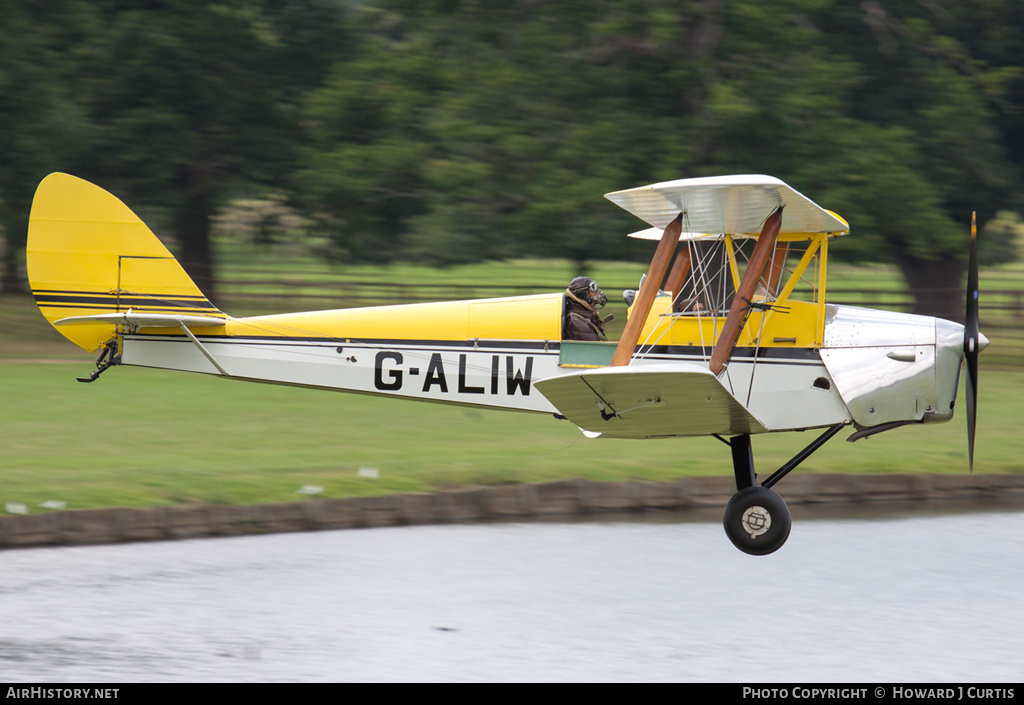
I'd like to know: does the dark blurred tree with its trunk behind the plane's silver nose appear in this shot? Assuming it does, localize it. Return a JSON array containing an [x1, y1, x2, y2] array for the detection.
[[802, 0, 1024, 319]]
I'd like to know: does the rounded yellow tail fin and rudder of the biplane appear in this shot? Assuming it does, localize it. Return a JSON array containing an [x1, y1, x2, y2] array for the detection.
[[27, 173, 220, 353]]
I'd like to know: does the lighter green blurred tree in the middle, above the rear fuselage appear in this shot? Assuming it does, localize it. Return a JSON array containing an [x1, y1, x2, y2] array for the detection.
[[298, 1, 696, 268]]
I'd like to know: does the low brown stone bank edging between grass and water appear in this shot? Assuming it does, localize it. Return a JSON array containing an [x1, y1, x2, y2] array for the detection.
[[0, 473, 1024, 548]]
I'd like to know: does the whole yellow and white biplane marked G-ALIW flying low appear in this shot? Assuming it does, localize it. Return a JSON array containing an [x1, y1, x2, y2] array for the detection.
[[27, 173, 988, 554]]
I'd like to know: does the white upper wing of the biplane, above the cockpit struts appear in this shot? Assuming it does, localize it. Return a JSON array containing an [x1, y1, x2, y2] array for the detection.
[[605, 174, 850, 239]]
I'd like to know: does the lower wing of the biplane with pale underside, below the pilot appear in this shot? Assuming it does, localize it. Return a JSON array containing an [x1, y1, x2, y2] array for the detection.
[[534, 363, 768, 439]]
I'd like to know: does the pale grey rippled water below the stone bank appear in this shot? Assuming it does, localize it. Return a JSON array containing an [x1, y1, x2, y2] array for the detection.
[[0, 511, 1024, 682]]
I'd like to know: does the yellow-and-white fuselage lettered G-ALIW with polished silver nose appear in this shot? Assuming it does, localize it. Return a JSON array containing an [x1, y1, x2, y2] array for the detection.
[[116, 293, 963, 436]]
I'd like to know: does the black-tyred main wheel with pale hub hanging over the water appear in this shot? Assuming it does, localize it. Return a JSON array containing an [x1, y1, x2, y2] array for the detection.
[[722, 487, 793, 555]]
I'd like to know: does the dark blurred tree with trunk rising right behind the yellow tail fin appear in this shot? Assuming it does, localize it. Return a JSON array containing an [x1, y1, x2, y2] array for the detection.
[[52, 0, 347, 297]]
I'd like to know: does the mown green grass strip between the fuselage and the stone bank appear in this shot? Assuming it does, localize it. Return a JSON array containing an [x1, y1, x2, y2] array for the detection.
[[0, 361, 1024, 511]]
